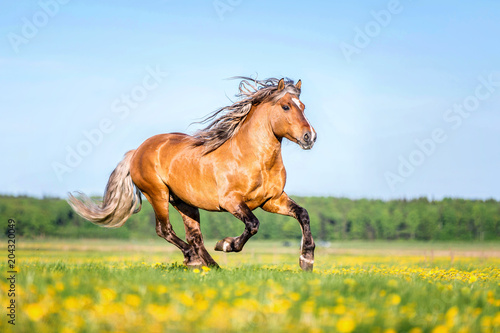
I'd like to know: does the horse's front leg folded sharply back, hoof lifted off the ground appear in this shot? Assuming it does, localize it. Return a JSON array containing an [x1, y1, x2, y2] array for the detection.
[[215, 197, 259, 252]]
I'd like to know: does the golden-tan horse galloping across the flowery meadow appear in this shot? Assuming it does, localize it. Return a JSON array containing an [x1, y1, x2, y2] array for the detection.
[[68, 77, 317, 271]]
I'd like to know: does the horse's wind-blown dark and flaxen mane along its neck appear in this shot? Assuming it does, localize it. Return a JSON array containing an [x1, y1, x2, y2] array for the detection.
[[194, 76, 300, 154]]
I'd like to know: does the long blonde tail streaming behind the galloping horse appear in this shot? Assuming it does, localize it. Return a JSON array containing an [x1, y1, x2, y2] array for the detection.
[[68, 150, 142, 228]]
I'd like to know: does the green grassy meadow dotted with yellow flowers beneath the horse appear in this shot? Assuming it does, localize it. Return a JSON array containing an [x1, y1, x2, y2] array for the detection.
[[0, 239, 500, 333]]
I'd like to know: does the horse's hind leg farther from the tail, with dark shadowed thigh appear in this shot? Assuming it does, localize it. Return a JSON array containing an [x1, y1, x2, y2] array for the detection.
[[171, 198, 219, 267]]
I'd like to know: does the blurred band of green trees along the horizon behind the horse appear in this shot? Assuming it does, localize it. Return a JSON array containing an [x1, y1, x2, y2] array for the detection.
[[0, 196, 500, 241]]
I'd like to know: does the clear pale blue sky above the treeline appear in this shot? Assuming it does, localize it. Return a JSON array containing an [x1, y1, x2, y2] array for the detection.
[[0, 0, 500, 199]]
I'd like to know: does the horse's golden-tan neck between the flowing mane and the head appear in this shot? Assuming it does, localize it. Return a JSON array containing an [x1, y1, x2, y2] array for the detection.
[[233, 103, 281, 162]]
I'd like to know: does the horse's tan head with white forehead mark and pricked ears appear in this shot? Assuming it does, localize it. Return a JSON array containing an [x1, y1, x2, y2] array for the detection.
[[270, 79, 317, 149]]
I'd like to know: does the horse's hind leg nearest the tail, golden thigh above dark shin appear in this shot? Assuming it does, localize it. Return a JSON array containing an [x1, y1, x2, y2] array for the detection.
[[143, 190, 202, 266]]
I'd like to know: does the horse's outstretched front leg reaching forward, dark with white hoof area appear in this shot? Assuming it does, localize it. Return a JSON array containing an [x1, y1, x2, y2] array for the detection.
[[262, 192, 315, 271]]
